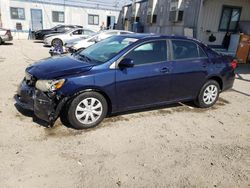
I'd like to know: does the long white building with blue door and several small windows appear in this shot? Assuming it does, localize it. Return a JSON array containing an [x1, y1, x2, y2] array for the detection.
[[0, 0, 120, 39]]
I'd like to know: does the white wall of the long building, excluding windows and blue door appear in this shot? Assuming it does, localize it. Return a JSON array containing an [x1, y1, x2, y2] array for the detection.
[[0, 0, 119, 39]]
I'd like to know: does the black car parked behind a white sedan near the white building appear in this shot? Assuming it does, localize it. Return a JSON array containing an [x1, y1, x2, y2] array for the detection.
[[34, 25, 82, 40]]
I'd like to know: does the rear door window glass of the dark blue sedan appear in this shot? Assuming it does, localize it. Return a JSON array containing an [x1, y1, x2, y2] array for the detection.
[[172, 40, 199, 60]]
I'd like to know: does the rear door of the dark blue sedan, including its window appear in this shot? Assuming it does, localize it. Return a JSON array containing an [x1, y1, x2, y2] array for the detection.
[[170, 39, 209, 100]]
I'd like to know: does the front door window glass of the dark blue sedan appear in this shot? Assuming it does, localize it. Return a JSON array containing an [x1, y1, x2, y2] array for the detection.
[[125, 40, 167, 65]]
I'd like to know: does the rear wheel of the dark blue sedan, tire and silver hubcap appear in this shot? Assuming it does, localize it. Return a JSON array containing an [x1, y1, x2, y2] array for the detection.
[[195, 80, 220, 108]]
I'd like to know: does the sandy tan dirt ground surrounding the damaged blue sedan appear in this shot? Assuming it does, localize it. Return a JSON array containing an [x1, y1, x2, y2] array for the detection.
[[0, 40, 250, 188]]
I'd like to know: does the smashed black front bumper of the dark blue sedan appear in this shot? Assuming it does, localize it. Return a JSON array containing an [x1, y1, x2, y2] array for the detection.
[[14, 81, 66, 126]]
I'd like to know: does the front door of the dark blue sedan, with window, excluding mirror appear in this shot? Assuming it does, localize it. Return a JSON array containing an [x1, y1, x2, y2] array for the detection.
[[116, 40, 170, 110]]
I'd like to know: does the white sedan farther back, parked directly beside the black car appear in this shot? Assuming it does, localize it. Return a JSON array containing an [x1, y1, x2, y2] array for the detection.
[[43, 28, 95, 47]]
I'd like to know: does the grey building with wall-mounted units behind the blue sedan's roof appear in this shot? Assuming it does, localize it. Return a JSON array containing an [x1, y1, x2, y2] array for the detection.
[[118, 0, 250, 45]]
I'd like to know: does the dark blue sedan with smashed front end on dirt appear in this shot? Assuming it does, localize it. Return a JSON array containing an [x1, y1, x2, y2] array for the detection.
[[15, 34, 237, 129]]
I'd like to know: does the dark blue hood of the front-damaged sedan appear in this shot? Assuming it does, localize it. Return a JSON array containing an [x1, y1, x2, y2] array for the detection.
[[26, 55, 94, 80]]
